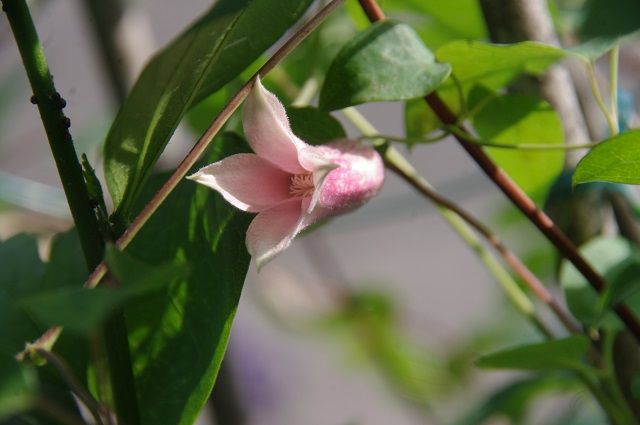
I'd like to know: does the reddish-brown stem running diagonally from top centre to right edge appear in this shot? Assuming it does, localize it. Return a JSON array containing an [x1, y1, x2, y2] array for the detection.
[[359, 0, 640, 342]]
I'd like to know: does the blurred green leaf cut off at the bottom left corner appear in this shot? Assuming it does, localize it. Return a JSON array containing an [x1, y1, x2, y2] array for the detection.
[[0, 352, 37, 423]]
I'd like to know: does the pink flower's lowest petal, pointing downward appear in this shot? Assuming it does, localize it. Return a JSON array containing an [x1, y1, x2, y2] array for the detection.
[[246, 199, 304, 270]]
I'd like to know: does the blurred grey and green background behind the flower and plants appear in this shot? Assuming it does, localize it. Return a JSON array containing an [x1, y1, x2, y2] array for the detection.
[[0, 0, 640, 425]]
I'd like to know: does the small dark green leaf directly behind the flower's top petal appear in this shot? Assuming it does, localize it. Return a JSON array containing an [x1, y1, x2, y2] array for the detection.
[[287, 107, 347, 145]]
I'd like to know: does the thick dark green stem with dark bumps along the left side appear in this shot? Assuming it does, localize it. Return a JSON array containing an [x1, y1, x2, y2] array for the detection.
[[2, 0, 139, 425]]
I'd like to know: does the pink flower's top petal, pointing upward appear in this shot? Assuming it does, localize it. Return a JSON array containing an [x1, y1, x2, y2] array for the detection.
[[242, 78, 308, 174]]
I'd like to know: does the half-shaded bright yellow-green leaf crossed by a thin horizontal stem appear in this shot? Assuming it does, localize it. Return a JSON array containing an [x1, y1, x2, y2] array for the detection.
[[473, 94, 564, 199]]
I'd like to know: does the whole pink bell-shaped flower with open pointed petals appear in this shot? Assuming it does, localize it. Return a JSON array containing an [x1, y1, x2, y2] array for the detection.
[[188, 79, 384, 270]]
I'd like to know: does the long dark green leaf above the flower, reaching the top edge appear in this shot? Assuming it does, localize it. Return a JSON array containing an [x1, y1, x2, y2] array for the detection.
[[105, 0, 311, 219]]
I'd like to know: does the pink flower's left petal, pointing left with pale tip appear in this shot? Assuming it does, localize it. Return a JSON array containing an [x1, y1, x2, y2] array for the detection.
[[187, 153, 291, 212]]
